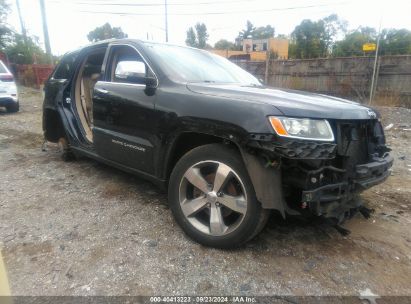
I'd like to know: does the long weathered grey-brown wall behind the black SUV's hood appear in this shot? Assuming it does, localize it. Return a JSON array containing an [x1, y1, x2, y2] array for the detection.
[[237, 56, 411, 107]]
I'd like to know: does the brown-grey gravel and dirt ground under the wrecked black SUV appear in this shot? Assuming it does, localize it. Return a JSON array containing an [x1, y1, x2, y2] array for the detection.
[[0, 89, 411, 296]]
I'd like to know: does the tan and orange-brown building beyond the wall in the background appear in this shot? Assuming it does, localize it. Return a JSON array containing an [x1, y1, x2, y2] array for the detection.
[[211, 38, 288, 61]]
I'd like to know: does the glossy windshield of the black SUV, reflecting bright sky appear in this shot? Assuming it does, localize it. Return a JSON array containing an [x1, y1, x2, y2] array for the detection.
[[145, 42, 261, 85]]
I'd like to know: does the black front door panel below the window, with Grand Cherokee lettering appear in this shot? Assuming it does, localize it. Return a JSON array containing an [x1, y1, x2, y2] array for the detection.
[[93, 81, 155, 173]]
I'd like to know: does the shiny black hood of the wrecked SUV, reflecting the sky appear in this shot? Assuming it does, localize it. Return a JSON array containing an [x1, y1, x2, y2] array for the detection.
[[187, 83, 379, 119]]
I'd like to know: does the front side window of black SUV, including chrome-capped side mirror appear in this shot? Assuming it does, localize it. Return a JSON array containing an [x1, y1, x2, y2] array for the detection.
[[111, 46, 147, 84]]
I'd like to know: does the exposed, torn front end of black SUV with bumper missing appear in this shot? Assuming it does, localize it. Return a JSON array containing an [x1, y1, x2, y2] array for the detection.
[[244, 120, 393, 223]]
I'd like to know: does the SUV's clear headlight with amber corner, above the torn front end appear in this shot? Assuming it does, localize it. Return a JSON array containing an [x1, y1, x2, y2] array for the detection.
[[269, 116, 334, 141]]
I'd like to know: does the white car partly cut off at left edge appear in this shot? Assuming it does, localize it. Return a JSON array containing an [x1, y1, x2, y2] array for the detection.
[[0, 60, 19, 112]]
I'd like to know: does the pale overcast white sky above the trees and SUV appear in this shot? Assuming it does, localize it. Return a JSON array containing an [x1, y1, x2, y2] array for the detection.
[[8, 0, 411, 55]]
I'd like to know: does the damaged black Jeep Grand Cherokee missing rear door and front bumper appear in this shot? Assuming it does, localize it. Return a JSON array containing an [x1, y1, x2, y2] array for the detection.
[[43, 40, 393, 248]]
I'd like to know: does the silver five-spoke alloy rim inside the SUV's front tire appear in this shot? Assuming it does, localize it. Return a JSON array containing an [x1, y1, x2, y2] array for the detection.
[[179, 160, 247, 236]]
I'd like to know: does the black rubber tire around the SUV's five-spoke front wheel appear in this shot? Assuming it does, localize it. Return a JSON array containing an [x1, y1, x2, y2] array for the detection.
[[168, 144, 270, 248]]
